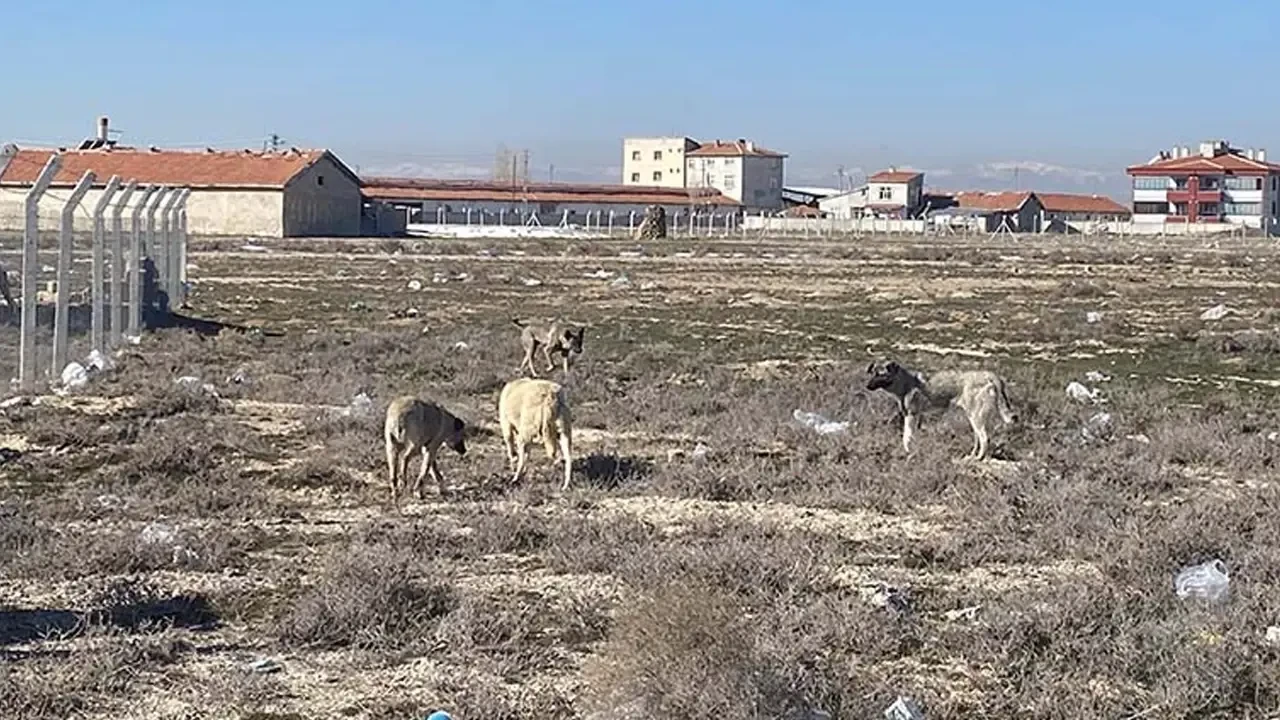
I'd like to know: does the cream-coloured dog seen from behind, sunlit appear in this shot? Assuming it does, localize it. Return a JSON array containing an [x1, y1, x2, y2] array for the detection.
[[498, 378, 573, 491]]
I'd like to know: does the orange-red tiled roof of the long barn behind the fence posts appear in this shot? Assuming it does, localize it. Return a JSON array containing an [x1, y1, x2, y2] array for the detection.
[[0, 147, 343, 188]]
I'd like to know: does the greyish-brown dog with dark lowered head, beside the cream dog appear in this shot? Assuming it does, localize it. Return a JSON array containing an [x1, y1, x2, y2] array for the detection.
[[383, 395, 467, 507]]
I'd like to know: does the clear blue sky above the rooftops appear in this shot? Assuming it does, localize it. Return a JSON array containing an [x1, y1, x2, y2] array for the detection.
[[0, 0, 1280, 193]]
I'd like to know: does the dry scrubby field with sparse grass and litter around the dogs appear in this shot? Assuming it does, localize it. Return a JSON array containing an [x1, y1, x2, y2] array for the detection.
[[0, 230, 1280, 720]]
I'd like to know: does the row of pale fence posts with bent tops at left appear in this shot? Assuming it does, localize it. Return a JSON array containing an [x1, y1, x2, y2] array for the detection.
[[15, 148, 189, 392]]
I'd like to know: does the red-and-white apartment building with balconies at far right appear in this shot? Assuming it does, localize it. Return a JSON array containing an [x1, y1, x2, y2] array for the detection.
[[1126, 140, 1280, 231]]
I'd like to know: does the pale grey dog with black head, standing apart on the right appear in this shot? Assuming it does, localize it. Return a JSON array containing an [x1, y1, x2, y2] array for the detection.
[[867, 360, 1018, 460]]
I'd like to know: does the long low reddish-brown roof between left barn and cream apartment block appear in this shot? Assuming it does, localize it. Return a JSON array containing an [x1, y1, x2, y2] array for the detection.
[[361, 177, 740, 206]]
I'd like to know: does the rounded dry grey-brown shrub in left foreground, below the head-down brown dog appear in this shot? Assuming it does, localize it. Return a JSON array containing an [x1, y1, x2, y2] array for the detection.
[[274, 538, 457, 652]]
